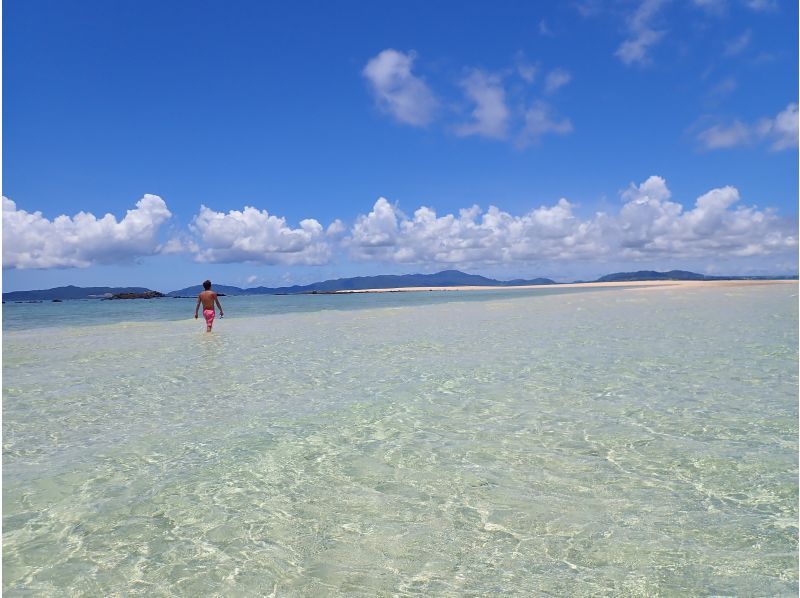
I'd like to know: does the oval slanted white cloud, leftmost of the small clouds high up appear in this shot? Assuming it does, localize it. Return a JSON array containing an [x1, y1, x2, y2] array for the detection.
[[362, 48, 438, 126]]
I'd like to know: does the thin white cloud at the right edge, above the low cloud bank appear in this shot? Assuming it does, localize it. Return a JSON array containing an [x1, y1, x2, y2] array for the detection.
[[697, 103, 798, 151]]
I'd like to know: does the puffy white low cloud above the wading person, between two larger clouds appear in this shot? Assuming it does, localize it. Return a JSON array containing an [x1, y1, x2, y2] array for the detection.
[[190, 206, 331, 265]]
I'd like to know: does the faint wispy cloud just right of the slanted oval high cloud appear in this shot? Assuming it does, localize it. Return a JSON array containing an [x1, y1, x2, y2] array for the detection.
[[456, 70, 510, 139]]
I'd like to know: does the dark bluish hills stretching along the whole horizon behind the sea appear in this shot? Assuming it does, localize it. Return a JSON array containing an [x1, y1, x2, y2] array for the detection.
[[3, 270, 797, 301]]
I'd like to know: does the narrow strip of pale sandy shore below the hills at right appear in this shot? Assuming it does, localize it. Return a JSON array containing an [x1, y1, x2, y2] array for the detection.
[[330, 279, 798, 295]]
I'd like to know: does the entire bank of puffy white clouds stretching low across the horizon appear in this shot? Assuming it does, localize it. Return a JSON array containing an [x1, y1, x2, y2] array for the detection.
[[3, 176, 798, 269]]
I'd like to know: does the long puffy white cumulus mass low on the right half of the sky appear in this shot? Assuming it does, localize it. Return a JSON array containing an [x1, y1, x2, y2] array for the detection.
[[344, 176, 797, 266]]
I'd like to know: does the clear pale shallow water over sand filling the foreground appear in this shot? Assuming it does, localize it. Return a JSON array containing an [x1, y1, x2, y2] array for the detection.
[[3, 284, 798, 596]]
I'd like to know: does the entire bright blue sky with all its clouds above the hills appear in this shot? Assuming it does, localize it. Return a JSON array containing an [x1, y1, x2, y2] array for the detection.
[[2, 0, 798, 291]]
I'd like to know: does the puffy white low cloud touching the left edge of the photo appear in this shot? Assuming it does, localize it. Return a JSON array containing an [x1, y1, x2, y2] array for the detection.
[[3, 195, 172, 269]]
